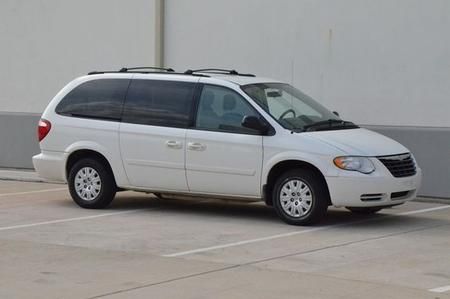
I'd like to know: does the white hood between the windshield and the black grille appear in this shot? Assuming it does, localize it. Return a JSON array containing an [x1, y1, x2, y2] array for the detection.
[[311, 128, 409, 157]]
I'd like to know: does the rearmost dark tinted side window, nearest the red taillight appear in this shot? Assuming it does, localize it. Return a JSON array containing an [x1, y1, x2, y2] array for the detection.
[[56, 79, 130, 121]]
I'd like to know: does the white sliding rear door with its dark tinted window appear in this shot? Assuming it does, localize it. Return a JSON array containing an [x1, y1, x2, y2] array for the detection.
[[120, 75, 198, 191]]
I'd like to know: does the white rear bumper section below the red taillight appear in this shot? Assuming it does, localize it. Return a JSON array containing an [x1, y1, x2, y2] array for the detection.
[[33, 151, 68, 182]]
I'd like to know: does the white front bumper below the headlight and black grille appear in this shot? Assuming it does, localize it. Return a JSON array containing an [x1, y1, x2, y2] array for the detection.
[[326, 168, 422, 207]]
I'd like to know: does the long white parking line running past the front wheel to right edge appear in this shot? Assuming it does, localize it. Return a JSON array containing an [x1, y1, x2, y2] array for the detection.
[[162, 205, 450, 257]]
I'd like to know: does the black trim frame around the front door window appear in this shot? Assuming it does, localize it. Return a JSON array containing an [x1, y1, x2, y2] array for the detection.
[[188, 82, 276, 136]]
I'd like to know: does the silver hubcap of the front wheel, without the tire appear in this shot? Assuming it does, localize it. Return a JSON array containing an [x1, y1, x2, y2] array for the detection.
[[280, 179, 312, 217]]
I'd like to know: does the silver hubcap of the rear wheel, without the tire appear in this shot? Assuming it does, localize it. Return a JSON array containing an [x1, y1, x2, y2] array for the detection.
[[75, 167, 102, 201]]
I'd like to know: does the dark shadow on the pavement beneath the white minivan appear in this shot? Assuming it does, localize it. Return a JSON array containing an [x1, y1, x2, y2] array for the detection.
[[88, 192, 450, 228]]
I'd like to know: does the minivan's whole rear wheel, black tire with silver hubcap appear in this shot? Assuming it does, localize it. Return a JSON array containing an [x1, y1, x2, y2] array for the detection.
[[68, 158, 117, 209]]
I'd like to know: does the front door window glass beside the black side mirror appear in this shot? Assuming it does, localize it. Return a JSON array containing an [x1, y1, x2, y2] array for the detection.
[[195, 85, 259, 134]]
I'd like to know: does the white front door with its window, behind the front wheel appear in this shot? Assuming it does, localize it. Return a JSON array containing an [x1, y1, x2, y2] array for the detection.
[[186, 84, 263, 197]]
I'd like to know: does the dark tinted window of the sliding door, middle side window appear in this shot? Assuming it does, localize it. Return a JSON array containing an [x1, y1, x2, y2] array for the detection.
[[122, 79, 195, 128]]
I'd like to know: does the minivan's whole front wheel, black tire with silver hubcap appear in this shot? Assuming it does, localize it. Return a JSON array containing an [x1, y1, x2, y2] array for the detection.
[[272, 169, 330, 225]]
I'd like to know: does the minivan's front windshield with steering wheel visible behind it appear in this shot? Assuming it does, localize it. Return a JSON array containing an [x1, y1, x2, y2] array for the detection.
[[241, 83, 340, 130]]
